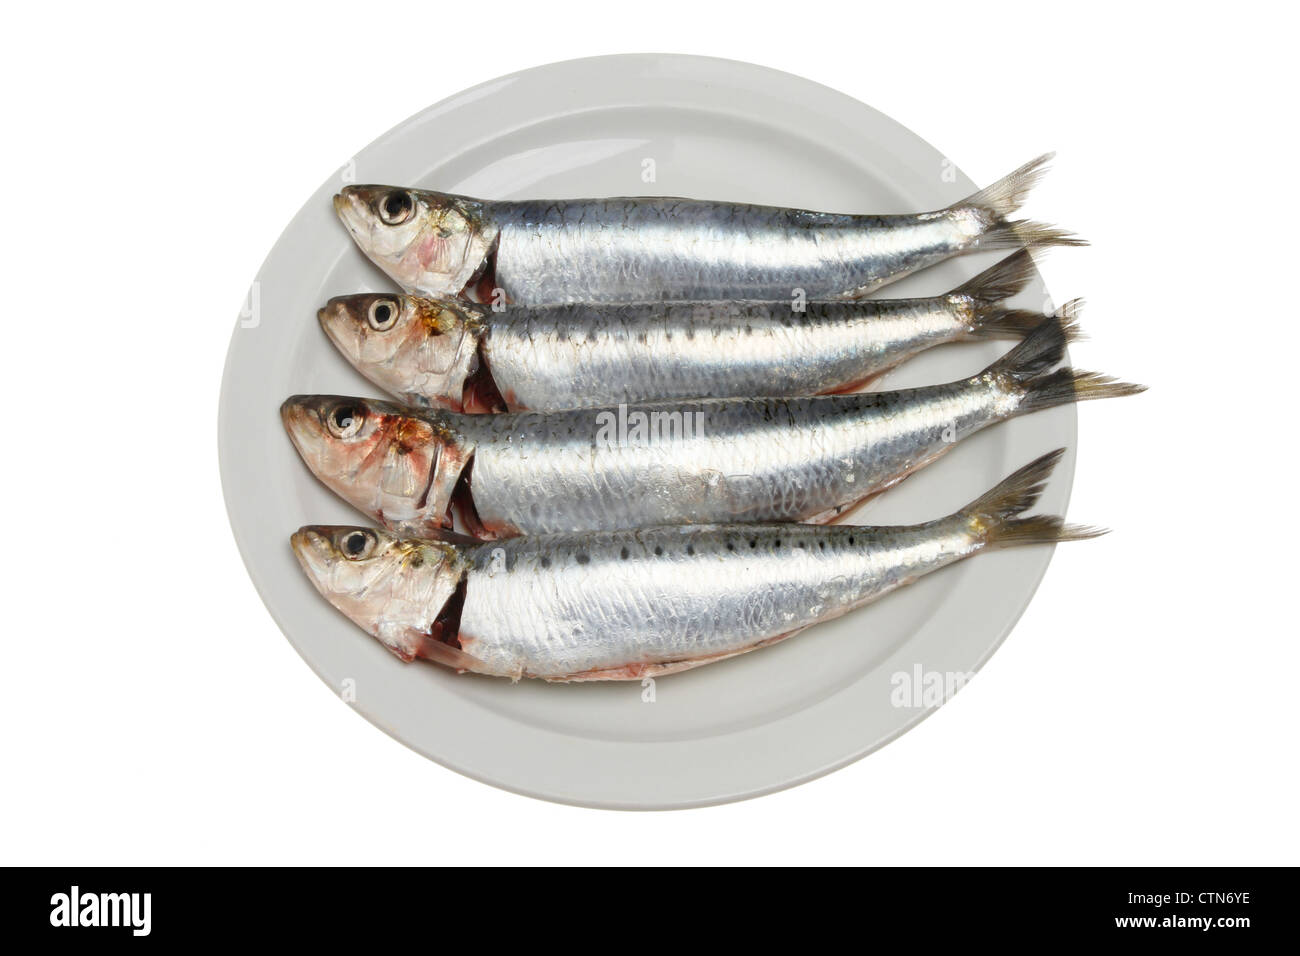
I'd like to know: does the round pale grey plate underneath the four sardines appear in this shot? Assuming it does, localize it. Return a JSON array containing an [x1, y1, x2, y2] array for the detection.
[[218, 55, 1075, 809]]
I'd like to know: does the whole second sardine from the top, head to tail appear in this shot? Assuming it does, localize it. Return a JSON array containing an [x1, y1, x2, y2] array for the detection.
[[317, 250, 1066, 412]]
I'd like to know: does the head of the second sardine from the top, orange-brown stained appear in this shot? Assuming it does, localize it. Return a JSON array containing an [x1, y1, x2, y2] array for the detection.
[[317, 293, 484, 411]]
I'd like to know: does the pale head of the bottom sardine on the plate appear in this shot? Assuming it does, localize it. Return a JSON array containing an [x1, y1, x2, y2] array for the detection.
[[290, 524, 464, 661]]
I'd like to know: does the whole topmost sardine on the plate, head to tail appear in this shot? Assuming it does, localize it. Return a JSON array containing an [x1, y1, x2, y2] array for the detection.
[[334, 153, 1084, 306]]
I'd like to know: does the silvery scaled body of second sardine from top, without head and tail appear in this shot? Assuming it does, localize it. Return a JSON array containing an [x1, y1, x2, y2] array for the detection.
[[484, 302, 969, 410]]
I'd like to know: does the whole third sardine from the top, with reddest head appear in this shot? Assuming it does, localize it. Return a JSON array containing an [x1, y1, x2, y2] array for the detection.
[[281, 319, 1141, 538]]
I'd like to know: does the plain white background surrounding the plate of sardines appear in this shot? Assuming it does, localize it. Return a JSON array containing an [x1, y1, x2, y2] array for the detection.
[[0, 0, 1300, 864]]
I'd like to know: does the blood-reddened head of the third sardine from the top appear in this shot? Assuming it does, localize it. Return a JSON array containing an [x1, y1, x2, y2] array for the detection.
[[280, 395, 469, 535]]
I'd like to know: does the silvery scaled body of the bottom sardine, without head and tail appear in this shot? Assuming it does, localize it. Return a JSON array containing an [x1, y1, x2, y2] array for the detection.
[[460, 519, 978, 679]]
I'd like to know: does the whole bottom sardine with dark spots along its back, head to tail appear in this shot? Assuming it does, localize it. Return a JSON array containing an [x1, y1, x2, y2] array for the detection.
[[291, 449, 1104, 682]]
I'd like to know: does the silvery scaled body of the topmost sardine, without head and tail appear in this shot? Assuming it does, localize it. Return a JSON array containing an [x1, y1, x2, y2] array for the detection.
[[490, 199, 956, 304]]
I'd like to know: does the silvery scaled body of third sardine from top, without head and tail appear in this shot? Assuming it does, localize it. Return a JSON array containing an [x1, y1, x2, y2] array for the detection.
[[457, 381, 1006, 533]]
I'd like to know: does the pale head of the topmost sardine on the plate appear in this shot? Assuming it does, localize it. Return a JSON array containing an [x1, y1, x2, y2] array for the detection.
[[334, 186, 497, 295]]
